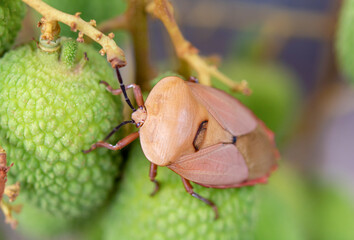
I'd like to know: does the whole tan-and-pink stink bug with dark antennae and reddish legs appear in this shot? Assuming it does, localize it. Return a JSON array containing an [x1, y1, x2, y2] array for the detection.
[[85, 68, 278, 218]]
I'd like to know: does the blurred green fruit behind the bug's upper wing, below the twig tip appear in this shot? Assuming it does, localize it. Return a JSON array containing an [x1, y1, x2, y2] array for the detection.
[[213, 61, 301, 143]]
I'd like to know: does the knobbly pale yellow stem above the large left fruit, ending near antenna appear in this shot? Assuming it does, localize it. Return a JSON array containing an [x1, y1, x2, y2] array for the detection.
[[22, 0, 126, 68]]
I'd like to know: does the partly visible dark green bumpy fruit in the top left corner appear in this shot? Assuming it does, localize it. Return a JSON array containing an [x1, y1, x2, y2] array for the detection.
[[0, 0, 25, 56]]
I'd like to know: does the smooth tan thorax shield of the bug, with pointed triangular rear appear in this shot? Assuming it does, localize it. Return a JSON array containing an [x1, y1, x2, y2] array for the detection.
[[139, 77, 232, 166]]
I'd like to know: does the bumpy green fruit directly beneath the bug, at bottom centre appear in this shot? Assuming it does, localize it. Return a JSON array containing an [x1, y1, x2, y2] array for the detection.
[[103, 144, 257, 240]]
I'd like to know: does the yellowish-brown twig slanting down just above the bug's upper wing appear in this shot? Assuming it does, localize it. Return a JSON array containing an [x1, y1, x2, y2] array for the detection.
[[146, 0, 251, 94]]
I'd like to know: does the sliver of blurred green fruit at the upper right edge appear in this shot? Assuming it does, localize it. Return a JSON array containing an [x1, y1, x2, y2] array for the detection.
[[336, 0, 354, 83]]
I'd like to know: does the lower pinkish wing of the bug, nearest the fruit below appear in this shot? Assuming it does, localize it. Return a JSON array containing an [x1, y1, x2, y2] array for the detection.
[[167, 143, 248, 188]]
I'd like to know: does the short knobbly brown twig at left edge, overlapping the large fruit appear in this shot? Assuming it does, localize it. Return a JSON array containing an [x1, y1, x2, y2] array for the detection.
[[0, 146, 21, 228]]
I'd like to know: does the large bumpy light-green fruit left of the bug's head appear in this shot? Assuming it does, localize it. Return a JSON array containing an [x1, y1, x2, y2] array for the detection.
[[0, 41, 121, 219]]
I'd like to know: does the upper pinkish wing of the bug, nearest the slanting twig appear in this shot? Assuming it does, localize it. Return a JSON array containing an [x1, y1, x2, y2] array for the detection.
[[188, 83, 257, 136]]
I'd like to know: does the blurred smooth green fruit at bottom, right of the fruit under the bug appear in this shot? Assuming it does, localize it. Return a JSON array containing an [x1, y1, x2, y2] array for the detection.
[[255, 165, 311, 240]]
